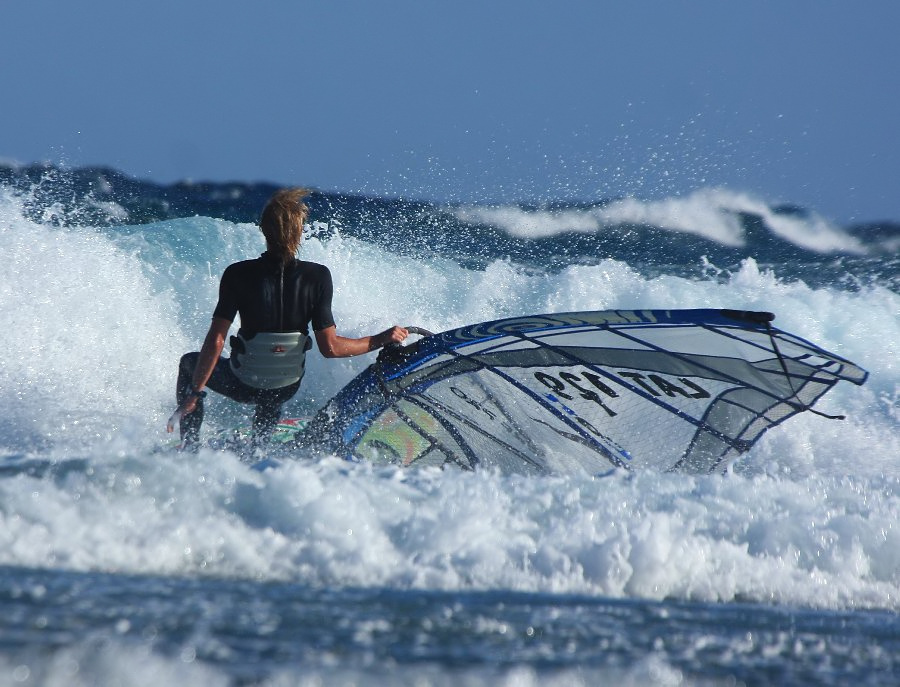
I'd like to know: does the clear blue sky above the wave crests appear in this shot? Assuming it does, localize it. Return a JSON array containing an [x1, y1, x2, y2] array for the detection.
[[0, 0, 900, 222]]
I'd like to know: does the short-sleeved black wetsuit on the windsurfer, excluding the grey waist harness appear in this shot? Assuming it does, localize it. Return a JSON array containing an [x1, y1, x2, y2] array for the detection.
[[176, 252, 334, 446]]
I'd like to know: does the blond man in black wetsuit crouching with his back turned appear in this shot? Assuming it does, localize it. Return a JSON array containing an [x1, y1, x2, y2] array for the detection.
[[167, 188, 408, 450]]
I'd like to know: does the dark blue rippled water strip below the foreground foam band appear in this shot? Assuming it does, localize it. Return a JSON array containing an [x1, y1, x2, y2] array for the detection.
[[0, 568, 900, 685]]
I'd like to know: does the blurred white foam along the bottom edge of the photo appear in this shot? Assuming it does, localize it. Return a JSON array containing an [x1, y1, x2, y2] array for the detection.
[[0, 640, 684, 687]]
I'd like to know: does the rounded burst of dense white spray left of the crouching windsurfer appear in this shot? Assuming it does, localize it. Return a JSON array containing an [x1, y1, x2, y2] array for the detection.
[[0, 194, 193, 448]]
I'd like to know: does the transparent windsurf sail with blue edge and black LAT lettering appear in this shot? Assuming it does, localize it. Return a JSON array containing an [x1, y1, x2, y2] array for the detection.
[[303, 309, 867, 473]]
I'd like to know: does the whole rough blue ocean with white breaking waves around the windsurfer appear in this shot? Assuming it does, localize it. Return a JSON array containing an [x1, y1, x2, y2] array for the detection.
[[0, 166, 900, 687]]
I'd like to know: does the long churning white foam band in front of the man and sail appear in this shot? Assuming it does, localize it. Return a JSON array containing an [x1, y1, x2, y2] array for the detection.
[[0, 452, 900, 609]]
